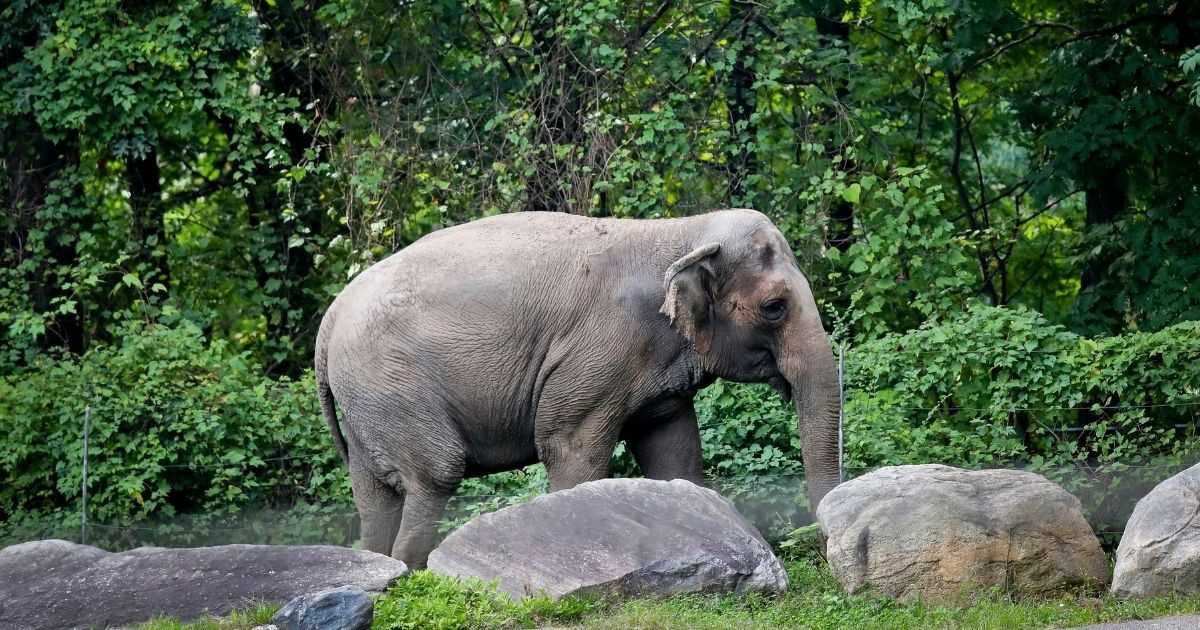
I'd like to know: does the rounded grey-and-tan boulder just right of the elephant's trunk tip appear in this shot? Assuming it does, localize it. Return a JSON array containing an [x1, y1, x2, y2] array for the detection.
[[817, 464, 1108, 605]]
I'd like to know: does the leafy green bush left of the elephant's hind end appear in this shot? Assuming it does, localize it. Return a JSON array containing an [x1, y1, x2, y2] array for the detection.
[[0, 323, 349, 522]]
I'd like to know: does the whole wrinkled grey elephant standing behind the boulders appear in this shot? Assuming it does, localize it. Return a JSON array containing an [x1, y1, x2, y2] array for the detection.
[[316, 210, 839, 569]]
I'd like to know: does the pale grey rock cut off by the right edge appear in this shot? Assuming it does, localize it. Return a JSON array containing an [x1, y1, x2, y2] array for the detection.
[[1112, 464, 1200, 598]]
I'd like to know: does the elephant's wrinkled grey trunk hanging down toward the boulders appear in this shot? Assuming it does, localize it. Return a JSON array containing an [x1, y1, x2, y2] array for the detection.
[[779, 314, 841, 515]]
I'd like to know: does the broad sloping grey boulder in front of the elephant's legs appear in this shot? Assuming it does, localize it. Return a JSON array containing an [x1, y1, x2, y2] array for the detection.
[[428, 479, 787, 599]]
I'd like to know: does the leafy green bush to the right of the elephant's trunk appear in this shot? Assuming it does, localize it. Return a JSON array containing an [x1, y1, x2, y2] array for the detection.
[[845, 305, 1200, 469]]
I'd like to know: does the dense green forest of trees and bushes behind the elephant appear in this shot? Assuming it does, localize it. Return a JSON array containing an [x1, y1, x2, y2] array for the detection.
[[0, 0, 1200, 544]]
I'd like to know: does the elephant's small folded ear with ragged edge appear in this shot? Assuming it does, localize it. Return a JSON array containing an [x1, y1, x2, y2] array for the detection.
[[659, 242, 721, 354]]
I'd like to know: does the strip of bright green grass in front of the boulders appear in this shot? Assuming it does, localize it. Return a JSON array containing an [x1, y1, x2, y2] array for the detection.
[[137, 558, 1200, 630]]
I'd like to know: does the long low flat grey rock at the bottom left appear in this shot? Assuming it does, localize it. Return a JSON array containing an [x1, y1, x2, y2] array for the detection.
[[0, 540, 408, 630]]
